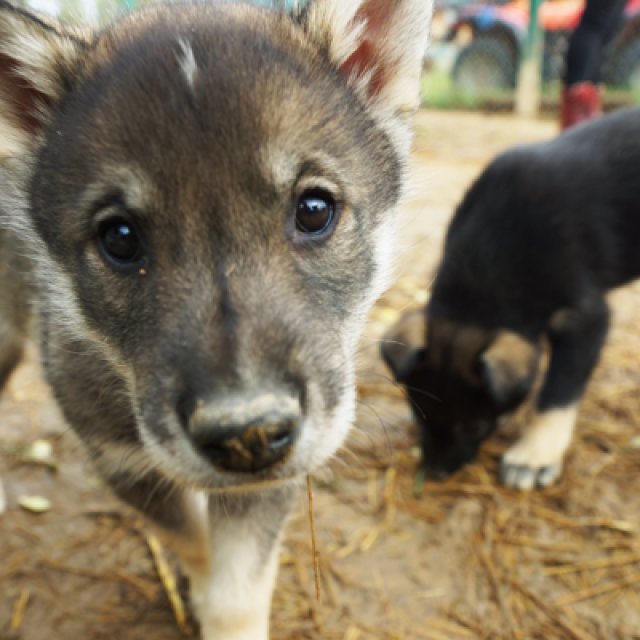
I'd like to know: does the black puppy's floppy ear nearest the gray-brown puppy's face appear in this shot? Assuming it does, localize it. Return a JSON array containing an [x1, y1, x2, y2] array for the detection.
[[380, 309, 427, 382]]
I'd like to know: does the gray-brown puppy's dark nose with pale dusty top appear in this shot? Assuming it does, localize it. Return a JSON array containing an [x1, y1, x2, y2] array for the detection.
[[189, 395, 301, 473]]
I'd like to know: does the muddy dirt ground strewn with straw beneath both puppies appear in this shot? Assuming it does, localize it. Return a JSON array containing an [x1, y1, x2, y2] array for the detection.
[[0, 112, 640, 640]]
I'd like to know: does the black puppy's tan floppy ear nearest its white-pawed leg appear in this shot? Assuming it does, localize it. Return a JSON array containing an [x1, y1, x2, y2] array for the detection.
[[478, 331, 540, 411]]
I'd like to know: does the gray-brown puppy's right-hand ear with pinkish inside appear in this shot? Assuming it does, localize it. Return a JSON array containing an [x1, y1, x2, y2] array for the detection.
[[301, 0, 432, 119]]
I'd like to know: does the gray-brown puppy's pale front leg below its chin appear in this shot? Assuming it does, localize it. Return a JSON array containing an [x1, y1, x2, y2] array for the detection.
[[107, 464, 294, 640]]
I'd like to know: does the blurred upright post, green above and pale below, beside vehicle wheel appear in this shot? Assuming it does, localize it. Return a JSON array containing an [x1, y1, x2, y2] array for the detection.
[[516, 0, 543, 118]]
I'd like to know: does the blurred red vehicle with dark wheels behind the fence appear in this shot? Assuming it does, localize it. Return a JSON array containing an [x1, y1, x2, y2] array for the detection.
[[447, 0, 640, 91]]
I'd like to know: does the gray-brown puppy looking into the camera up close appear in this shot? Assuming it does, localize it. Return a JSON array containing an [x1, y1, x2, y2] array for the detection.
[[0, 0, 431, 640]]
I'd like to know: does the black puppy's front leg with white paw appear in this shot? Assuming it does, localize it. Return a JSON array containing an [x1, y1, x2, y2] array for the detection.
[[501, 298, 609, 490]]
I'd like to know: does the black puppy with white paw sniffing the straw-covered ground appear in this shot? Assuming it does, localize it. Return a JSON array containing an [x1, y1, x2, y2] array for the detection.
[[382, 109, 640, 489]]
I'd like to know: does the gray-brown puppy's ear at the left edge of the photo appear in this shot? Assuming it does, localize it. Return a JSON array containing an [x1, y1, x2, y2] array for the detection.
[[0, 0, 89, 156]]
